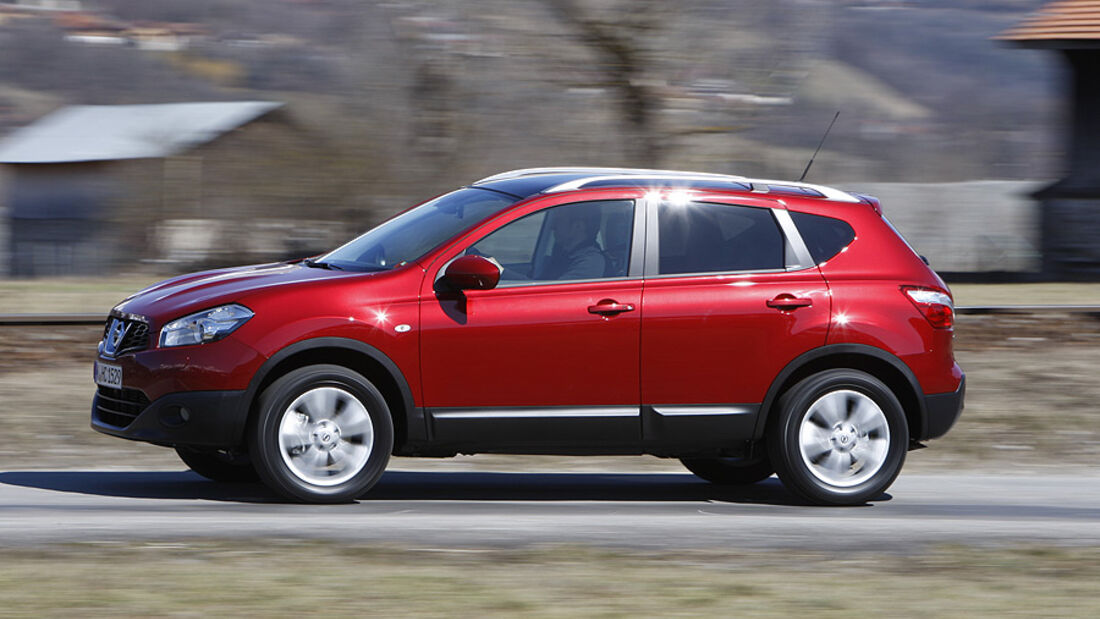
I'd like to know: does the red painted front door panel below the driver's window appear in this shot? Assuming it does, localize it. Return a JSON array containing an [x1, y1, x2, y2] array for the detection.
[[420, 280, 641, 408]]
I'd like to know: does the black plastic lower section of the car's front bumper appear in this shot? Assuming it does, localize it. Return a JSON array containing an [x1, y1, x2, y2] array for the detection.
[[91, 390, 249, 447]]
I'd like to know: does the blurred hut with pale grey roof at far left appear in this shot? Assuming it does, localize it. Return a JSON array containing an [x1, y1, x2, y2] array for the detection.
[[0, 101, 325, 277]]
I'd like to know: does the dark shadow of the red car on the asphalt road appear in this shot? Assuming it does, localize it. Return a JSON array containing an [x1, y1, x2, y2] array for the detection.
[[0, 471, 890, 506]]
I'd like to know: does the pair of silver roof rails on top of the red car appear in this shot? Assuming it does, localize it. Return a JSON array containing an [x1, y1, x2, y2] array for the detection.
[[474, 167, 861, 202]]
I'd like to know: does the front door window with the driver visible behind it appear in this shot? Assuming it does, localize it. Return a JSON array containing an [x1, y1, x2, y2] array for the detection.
[[466, 200, 634, 285]]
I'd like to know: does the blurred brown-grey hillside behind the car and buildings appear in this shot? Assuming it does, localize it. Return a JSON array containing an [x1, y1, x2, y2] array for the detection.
[[0, 0, 1059, 186]]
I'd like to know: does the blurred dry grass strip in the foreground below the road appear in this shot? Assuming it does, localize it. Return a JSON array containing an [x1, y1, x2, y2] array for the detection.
[[0, 540, 1100, 618]]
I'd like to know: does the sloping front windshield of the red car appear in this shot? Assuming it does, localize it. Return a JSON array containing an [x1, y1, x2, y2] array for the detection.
[[307, 187, 519, 270]]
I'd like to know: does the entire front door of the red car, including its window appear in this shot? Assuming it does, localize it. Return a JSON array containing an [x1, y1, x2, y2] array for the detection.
[[421, 200, 641, 452]]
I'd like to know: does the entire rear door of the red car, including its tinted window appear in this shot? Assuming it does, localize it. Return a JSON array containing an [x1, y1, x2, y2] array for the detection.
[[640, 198, 831, 447]]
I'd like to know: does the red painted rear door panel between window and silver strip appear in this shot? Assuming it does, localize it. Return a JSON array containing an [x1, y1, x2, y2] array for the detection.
[[641, 268, 829, 405]]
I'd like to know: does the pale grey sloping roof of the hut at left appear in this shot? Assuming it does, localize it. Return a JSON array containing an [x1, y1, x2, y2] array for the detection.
[[0, 101, 283, 164]]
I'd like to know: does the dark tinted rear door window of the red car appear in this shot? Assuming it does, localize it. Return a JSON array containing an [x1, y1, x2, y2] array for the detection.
[[657, 202, 785, 275]]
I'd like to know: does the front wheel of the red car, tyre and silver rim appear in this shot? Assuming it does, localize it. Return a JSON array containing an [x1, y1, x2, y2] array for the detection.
[[249, 365, 394, 502]]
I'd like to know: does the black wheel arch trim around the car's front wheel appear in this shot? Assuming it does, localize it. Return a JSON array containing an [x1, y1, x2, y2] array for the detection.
[[241, 338, 424, 450]]
